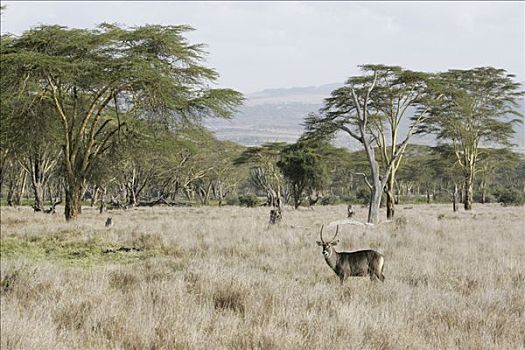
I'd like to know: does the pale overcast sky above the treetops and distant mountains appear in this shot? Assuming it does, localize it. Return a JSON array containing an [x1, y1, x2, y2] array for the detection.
[[1, 1, 525, 93]]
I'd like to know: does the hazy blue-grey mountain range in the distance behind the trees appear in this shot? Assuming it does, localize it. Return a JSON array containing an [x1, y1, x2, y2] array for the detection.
[[205, 83, 525, 152]]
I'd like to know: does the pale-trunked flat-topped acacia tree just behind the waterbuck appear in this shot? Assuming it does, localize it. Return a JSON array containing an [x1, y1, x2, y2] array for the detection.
[[306, 65, 432, 223]]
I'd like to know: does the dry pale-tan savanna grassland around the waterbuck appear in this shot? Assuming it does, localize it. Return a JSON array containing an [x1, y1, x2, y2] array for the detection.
[[0, 205, 525, 350]]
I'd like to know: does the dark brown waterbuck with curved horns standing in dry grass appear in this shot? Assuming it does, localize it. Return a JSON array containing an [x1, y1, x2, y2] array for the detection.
[[317, 225, 385, 283]]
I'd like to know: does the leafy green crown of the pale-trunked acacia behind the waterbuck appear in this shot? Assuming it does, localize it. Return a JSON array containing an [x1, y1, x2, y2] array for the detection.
[[305, 64, 431, 148]]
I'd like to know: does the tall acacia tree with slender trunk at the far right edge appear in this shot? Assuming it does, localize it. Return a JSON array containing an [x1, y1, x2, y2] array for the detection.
[[418, 67, 523, 210]]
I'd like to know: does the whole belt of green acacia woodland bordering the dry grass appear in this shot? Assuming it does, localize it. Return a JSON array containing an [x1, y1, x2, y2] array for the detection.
[[0, 24, 525, 223]]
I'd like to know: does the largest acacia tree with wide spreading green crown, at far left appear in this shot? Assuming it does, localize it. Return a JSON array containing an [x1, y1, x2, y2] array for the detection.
[[1, 24, 242, 220]]
